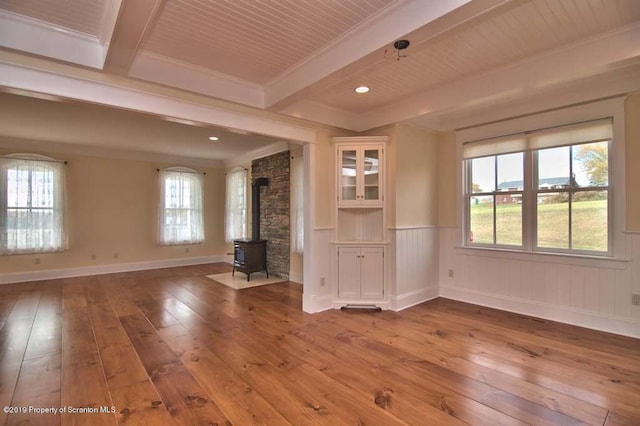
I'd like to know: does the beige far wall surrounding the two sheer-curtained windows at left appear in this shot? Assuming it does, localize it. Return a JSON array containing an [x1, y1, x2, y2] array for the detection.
[[0, 148, 225, 273]]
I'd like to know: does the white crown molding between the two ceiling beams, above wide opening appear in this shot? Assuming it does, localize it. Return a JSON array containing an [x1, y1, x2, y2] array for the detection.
[[129, 51, 264, 108]]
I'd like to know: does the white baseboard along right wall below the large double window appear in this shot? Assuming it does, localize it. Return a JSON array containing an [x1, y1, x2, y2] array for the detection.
[[440, 285, 640, 338]]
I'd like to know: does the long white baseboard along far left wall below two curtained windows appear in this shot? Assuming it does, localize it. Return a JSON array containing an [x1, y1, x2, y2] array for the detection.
[[0, 255, 225, 284]]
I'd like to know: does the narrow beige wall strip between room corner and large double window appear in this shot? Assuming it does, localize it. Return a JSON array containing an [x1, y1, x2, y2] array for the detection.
[[438, 132, 459, 226]]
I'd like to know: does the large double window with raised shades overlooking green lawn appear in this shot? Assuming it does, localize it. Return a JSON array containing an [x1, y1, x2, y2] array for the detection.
[[463, 119, 612, 255]]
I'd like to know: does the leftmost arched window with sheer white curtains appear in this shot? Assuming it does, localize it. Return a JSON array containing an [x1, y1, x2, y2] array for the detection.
[[0, 154, 67, 254]]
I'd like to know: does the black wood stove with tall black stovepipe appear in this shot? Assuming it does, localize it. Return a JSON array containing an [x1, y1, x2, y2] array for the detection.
[[231, 178, 269, 281]]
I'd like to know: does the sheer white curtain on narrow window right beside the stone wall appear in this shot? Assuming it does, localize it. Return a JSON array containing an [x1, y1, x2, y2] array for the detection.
[[224, 169, 247, 243]]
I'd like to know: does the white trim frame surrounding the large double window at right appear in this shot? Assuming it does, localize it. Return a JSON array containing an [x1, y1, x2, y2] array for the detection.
[[456, 97, 628, 262]]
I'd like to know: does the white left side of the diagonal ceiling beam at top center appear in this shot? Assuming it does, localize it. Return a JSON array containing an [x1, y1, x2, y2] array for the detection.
[[264, 0, 470, 108]]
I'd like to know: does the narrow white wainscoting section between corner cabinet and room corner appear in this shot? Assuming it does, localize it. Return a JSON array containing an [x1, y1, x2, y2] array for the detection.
[[387, 227, 439, 311]]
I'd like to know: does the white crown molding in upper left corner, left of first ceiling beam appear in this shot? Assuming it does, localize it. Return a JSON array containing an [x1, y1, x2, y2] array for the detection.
[[0, 10, 106, 69]]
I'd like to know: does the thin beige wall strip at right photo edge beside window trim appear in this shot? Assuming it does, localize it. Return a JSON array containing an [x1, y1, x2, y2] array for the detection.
[[625, 94, 640, 232]]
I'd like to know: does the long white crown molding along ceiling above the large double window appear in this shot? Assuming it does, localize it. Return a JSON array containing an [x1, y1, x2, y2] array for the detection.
[[358, 23, 640, 131]]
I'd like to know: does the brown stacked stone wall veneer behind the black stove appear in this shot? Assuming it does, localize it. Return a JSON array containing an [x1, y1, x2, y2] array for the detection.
[[251, 151, 291, 279]]
